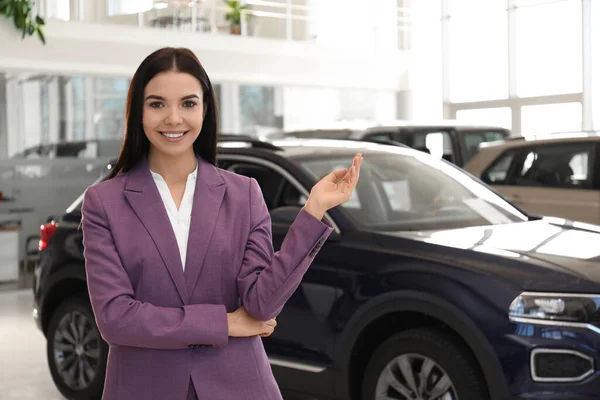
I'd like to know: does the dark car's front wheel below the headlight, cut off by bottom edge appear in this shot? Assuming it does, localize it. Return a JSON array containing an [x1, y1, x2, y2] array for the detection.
[[362, 329, 489, 400]]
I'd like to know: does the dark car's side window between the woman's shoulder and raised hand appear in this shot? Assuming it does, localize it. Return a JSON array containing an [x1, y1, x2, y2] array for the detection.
[[227, 162, 307, 211]]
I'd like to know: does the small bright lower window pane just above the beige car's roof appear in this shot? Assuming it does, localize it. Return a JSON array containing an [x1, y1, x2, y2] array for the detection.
[[521, 103, 581, 136]]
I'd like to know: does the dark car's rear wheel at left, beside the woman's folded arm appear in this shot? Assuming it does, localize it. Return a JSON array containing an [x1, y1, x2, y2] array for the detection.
[[47, 297, 108, 400]]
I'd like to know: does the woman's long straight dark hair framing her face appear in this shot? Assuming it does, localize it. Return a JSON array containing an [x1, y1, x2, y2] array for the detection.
[[106, 47, 218, 180]]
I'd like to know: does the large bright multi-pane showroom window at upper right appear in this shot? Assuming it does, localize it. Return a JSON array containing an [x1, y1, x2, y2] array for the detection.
[[441, 0, 600, 136]]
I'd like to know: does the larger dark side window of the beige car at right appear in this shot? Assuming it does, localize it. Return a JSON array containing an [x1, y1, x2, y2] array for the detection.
[[514, 144, 594, 189]]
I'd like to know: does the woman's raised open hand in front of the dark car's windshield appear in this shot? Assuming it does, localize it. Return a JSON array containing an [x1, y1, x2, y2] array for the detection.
[[304, 153, 363, 219]]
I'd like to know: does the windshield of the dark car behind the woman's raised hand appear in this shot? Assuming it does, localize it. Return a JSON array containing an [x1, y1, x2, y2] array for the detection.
[[298, 146, 527, 231]]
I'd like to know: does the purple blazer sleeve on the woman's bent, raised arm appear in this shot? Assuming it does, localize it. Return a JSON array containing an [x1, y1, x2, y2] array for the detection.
[[237, 178, 333, 321]]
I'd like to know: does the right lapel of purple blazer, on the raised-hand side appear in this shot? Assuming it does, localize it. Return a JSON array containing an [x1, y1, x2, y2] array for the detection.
[[185, 157, 226, 297]]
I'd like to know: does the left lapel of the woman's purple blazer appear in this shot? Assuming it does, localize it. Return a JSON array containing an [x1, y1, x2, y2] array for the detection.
[[125, 159, 188, 304]]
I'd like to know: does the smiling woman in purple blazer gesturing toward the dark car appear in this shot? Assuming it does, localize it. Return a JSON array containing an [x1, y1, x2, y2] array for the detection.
[[82, 48, 362, 400]]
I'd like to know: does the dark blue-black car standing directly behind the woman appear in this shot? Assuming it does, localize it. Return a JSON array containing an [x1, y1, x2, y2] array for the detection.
[[34, 138, 600, 400]]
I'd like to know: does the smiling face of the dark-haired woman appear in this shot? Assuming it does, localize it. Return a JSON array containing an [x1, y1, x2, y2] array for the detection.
[[142, 71, 204, 157]]
